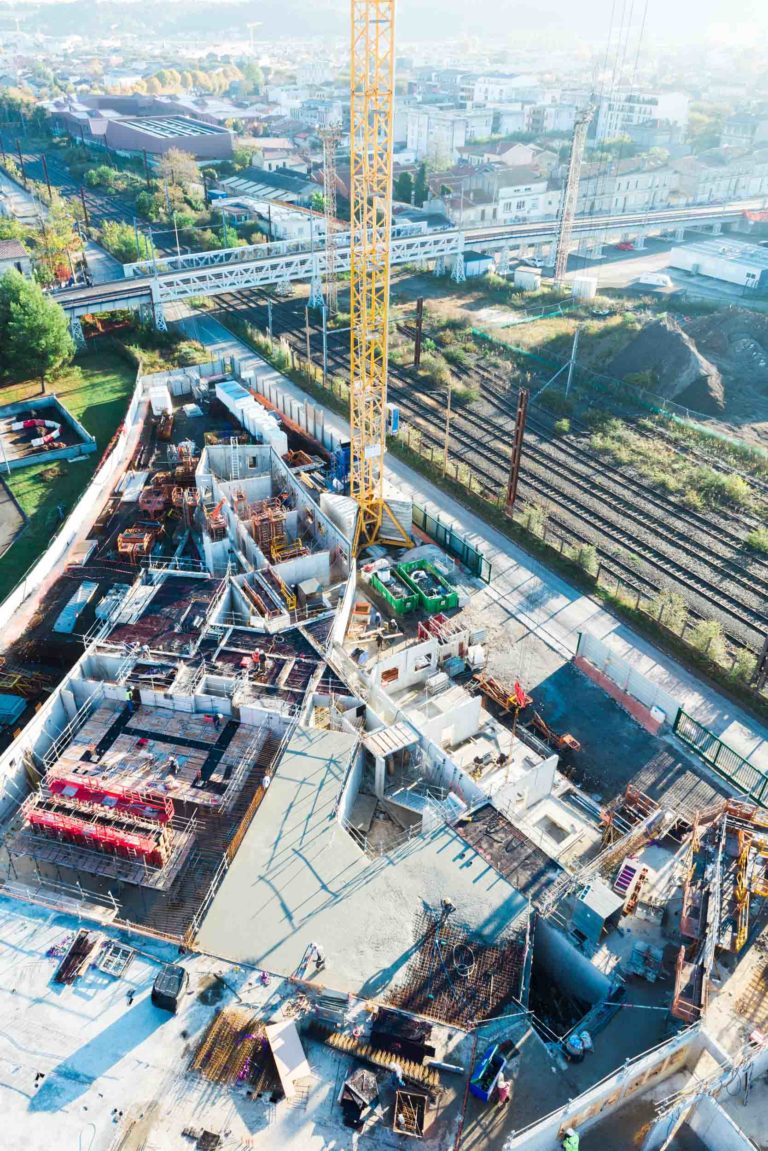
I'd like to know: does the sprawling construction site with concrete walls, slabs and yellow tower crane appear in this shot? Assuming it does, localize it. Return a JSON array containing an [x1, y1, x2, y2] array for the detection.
[[0, 0, 768, 1151]]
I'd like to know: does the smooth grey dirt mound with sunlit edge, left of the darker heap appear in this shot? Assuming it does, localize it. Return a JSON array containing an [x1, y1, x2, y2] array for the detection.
[[608, 317, 725, 416]]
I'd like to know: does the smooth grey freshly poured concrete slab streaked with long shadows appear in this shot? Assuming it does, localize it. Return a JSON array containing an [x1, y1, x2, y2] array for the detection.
[[198, 729, 527, 996]]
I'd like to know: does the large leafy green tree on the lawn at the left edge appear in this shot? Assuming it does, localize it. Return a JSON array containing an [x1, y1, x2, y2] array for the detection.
[[0, 272, 75, 391]]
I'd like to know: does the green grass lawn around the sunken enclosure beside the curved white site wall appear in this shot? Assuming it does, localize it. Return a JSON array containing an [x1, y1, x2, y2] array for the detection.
[[0, 352, 136, 600]]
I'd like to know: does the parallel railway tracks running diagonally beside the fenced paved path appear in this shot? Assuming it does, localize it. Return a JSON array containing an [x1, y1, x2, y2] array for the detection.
[[206, 290, 768, 649]]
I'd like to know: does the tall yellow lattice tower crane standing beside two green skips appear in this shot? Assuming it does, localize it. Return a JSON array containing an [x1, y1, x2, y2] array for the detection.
[[349, 0, 410, 552]]
